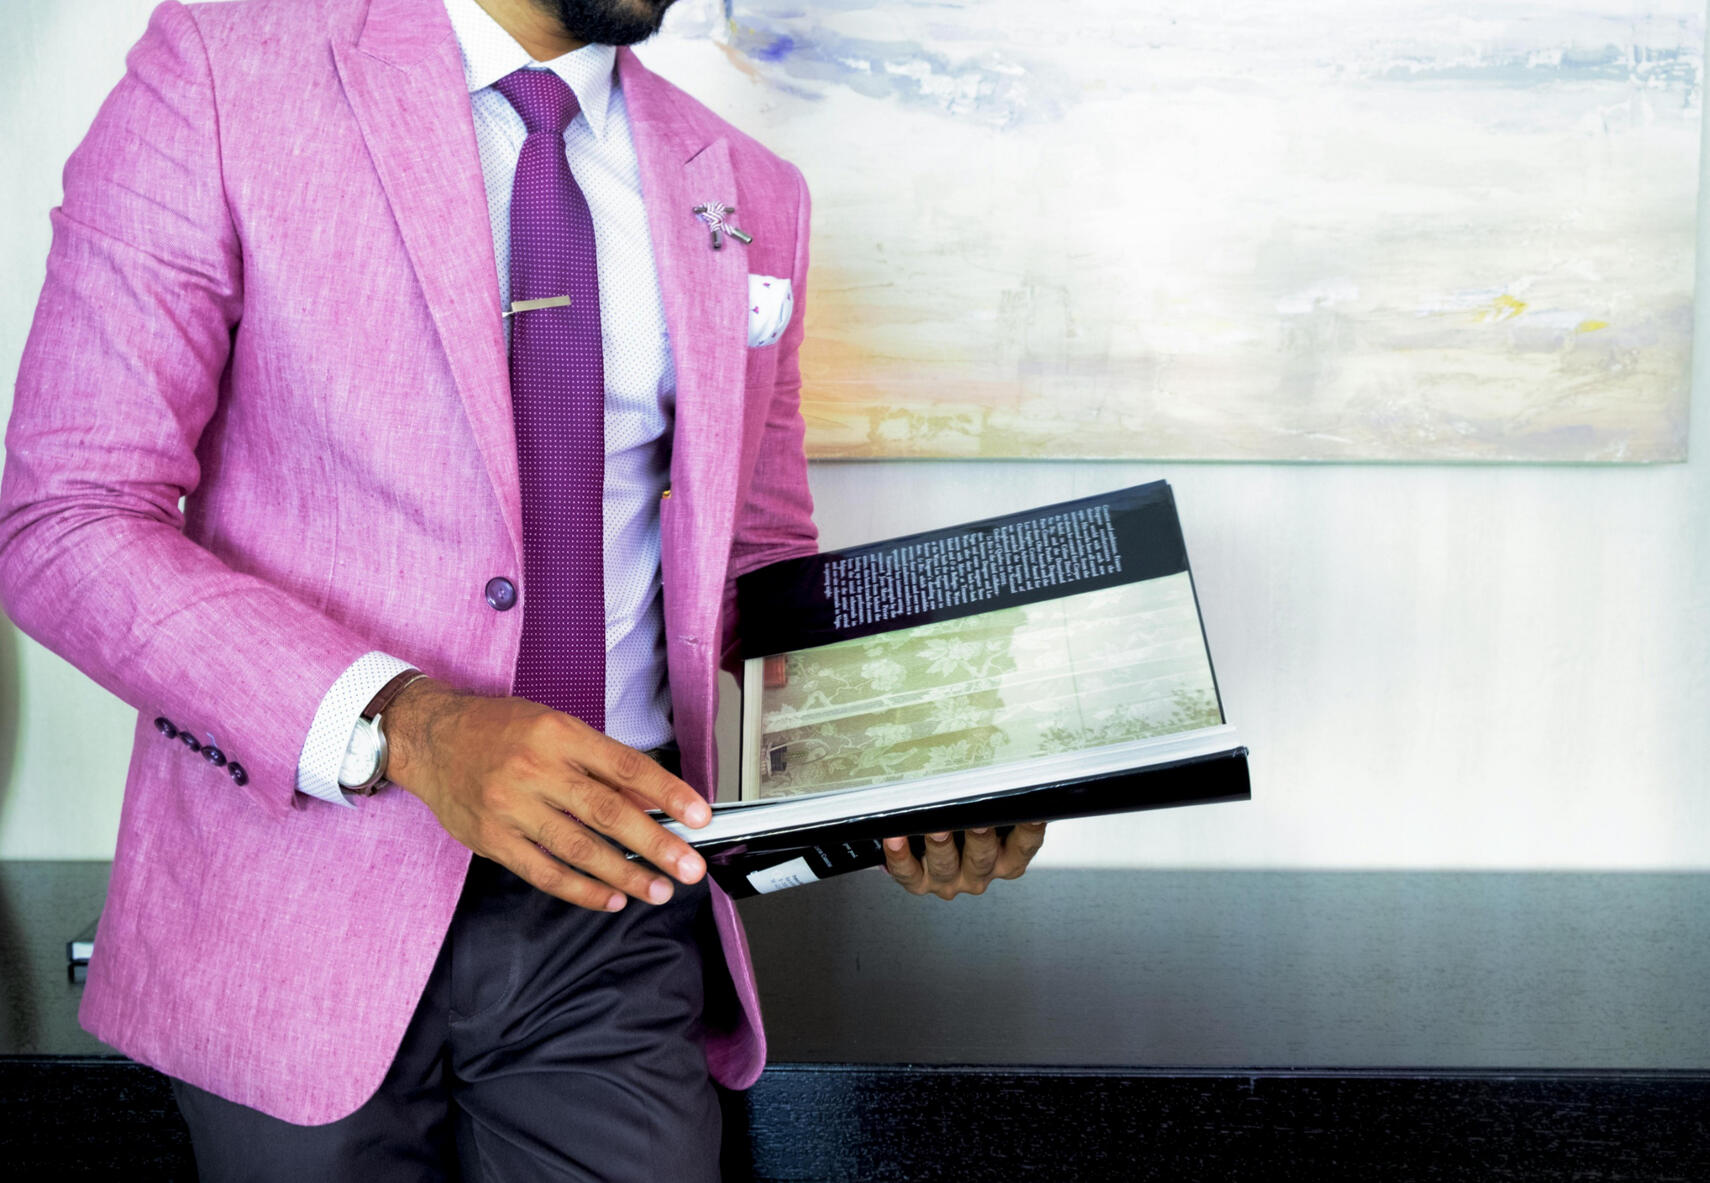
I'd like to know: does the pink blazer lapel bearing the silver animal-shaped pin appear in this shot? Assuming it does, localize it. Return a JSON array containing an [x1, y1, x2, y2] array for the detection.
[[617, 50, 747, 632]]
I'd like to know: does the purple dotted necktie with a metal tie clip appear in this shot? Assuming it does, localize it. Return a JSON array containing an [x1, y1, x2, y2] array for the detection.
[[494, 68, 605, 732]]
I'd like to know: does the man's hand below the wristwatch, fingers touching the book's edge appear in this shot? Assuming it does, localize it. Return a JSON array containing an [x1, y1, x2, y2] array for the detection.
[[383, 679, 713, 911]]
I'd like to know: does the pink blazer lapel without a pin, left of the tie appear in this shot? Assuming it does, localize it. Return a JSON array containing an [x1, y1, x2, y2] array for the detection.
[[333, 0, 522, 556]]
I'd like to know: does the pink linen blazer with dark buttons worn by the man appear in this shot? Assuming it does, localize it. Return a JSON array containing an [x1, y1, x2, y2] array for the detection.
[[0, 0, 816, 1123]]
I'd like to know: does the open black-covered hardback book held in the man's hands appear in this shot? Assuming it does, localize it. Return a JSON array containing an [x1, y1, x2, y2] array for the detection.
[[669, 480, 1250, 896]]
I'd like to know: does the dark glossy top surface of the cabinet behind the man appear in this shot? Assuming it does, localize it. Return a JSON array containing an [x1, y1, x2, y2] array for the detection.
[[0, 862, 1710, 1070]]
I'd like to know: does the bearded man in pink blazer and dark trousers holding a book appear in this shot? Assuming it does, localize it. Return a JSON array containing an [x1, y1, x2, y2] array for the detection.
[[0, 0, 1040, 1180]]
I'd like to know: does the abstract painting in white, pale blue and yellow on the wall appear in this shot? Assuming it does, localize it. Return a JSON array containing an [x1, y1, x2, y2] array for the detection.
[[643, 0, 1705, 462]]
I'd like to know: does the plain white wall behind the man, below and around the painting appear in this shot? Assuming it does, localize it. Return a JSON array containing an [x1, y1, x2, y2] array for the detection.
[[0, 0, 1710, 870]]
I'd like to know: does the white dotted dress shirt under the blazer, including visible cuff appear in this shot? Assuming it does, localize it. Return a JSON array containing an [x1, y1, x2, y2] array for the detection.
[[298, 0, 677, 803]]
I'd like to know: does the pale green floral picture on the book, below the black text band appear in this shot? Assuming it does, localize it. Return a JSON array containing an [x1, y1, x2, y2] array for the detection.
[[744, 571, 1223, 800]]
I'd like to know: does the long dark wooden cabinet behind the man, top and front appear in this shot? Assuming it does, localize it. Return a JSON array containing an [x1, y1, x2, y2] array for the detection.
[[0, 863, 1710, 1183]]
